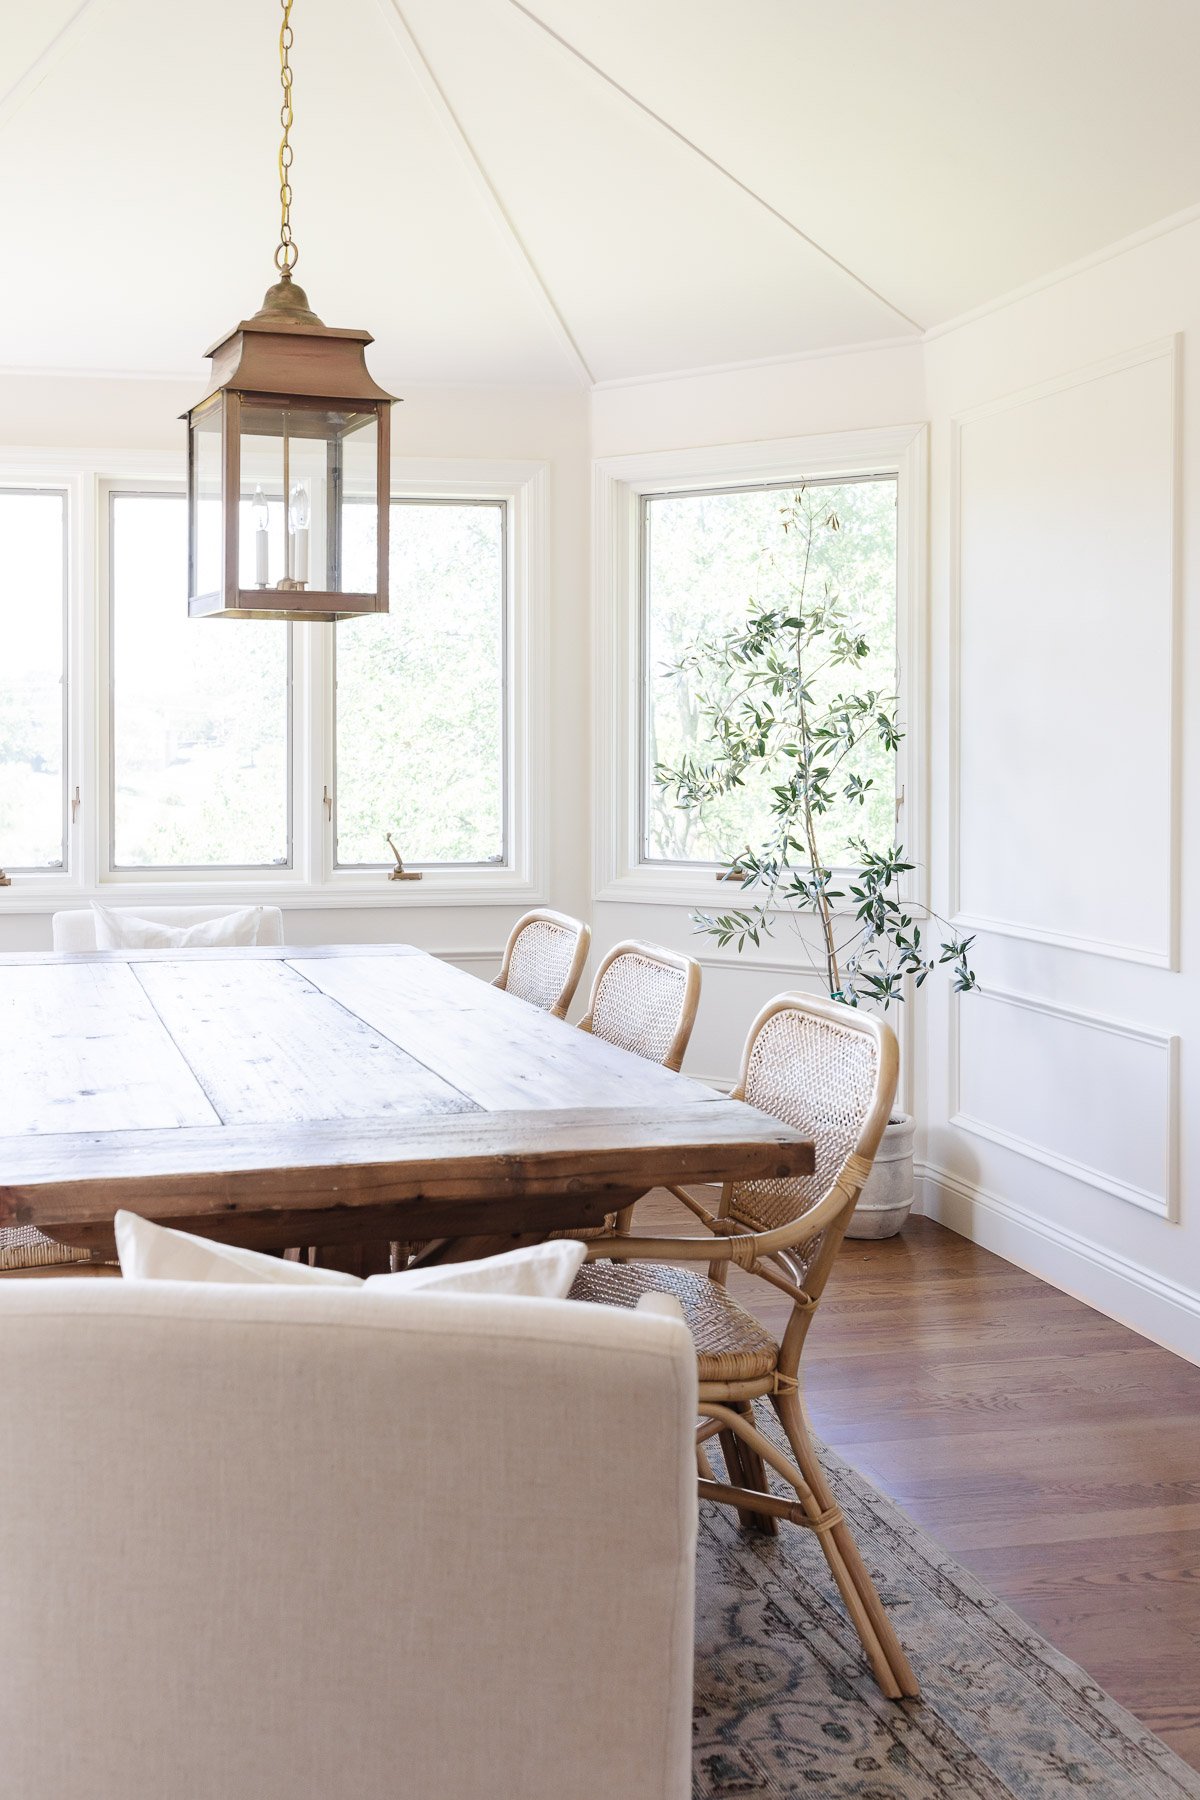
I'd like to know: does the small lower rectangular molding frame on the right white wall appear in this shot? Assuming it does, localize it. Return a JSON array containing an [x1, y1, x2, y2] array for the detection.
[[948, 986, 1178, 1222]]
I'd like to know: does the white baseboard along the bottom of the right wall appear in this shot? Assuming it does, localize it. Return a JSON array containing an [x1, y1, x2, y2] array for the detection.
[[918, 1163, 1200, 1363]]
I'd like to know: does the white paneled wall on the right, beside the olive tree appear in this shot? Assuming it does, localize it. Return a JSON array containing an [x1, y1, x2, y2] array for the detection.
[[923, 225, 1200, 1359]]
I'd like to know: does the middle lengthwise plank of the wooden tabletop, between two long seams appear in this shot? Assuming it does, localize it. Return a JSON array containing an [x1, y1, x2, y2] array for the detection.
[[135, 959, 475, 1125]]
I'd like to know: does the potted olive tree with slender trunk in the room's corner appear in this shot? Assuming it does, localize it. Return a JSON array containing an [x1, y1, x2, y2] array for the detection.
[[655, 486, 975, 1237]]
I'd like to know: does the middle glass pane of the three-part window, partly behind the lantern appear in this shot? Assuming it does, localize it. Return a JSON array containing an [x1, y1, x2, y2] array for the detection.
[[110, 491, 290, 869]]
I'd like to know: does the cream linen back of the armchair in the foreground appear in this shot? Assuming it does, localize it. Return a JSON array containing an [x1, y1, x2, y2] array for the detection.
[[0, 1278, 696, 1800]]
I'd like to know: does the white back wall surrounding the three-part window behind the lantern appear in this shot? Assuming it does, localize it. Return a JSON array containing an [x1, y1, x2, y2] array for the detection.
[[0, 374, 588, 974]]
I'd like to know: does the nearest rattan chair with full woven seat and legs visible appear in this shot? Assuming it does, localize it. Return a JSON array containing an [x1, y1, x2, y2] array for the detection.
[[572, 994, 918, 1699]]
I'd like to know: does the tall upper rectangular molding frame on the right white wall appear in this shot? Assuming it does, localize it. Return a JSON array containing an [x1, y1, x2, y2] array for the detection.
[[948, 335, 1182, 968]]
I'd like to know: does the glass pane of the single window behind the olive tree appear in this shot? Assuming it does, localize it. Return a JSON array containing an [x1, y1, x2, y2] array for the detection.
[[639, 475, 898, 866]]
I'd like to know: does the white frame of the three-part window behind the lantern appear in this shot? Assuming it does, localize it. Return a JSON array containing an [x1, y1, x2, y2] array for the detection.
[[0, 448, 549, 916]]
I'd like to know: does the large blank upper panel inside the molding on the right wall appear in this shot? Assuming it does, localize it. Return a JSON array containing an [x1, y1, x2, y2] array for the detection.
[[952, 338, 1178, 967]]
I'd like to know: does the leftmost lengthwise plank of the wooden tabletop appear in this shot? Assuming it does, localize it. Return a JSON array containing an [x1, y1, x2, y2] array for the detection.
[[0, 961, 218, 1134]]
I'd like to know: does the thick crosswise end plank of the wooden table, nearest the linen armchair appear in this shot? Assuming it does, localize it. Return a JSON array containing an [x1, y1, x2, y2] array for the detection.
[[0, 1096, 813, 1244]]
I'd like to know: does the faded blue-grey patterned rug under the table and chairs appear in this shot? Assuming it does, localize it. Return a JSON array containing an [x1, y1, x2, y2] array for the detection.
[[693, 1415, 1200, 1800]]
